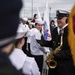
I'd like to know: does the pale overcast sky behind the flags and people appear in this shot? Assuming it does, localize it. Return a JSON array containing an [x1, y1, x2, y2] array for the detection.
[[20, 0, 75, 18]]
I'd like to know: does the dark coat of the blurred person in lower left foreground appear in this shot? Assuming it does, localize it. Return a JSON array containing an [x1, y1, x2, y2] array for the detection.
[[0, 51, 23, 75]]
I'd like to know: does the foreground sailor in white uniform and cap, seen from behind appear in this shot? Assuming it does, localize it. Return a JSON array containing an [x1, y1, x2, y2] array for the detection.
[[9, 25, 40, 75]]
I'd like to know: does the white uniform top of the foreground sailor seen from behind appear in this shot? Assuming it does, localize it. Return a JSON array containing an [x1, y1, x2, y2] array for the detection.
[[9, 48, 40, 75]]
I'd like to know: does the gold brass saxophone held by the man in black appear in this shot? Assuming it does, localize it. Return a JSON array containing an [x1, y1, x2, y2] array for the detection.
[[46, 30, 64, 69]]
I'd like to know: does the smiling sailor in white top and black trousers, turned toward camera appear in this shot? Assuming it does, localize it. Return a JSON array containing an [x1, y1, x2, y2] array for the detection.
[[30, 19, 45, 73]]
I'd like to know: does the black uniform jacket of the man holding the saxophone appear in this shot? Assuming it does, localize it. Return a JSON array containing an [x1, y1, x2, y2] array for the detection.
[[37, 27, 75, 75]]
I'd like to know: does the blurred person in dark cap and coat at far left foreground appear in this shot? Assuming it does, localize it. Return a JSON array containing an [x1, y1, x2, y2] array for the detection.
[[0, 0, 23, 75]]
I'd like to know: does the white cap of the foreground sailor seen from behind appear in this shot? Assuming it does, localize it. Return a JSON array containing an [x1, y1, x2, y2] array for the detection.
[[15, 24, 26, 39]]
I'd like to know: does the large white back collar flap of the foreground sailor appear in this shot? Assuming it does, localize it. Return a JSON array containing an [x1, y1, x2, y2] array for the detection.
[[9, 48, 27, 70]]
